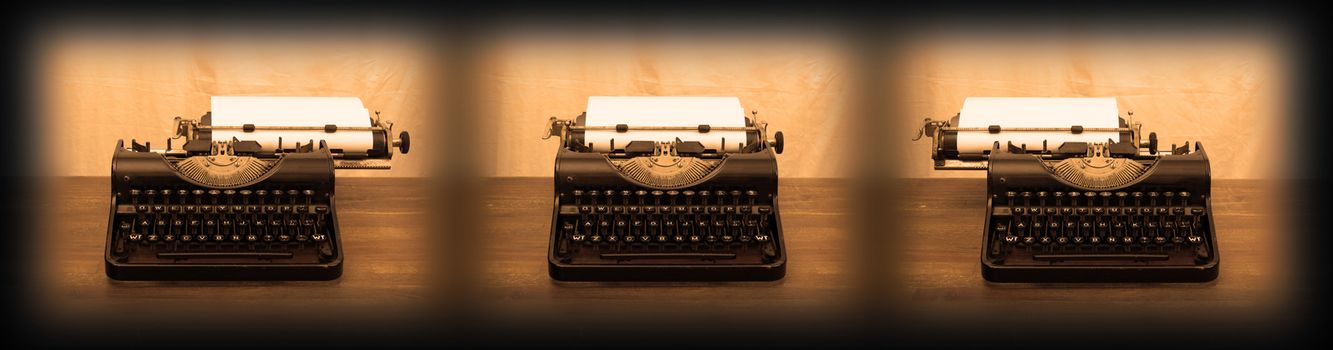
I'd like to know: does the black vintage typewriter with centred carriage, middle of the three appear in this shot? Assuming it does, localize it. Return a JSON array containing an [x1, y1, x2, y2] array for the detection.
[[545, 96, 786, 281]]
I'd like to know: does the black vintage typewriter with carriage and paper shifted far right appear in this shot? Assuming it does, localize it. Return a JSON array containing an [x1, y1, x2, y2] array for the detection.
[[105, 97, 411, 279]]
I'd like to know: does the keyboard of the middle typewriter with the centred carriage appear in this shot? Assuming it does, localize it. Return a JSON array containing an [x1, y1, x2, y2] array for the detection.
[[555, 189, 778, 263]]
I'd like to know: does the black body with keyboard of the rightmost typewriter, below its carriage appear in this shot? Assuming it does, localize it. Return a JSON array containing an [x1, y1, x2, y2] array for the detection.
[[982, 150, 1218, 282]]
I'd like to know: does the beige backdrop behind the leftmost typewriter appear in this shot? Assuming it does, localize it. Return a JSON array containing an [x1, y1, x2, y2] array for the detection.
[[35, 28, 439, 177]]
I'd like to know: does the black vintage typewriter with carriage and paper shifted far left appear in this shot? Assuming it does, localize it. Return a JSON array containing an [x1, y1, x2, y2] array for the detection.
[[917, 97, 1218, 282]]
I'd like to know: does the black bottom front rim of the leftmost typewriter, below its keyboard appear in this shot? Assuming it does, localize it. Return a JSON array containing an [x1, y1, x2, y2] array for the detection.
[[107, 261, 343, 281]]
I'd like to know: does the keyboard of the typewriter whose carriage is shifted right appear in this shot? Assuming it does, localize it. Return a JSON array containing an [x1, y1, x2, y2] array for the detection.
[[112, 188, 335, 263]]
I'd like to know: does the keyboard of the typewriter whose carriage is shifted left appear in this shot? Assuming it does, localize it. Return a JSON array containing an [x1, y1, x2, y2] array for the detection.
[[986, 190, 1213, 265]]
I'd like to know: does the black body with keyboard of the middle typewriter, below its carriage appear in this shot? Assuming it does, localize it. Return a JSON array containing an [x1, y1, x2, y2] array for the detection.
[[549, 149, 785, 281]]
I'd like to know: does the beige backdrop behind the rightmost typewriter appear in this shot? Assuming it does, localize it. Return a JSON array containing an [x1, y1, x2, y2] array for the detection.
[[889, 31, 1290, 178]]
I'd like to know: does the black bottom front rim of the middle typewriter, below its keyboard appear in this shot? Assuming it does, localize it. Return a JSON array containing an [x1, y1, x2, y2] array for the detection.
[[548, 261, 786, 282]]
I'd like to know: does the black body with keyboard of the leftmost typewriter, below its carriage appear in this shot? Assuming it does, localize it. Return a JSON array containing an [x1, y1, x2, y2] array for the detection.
[[107, 150, 343, 279]]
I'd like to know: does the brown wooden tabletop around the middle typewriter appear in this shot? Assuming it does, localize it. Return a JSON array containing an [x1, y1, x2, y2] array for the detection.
[[481, 178, 854, 331]]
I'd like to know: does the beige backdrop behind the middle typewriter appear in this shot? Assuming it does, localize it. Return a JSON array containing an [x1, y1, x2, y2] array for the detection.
[[483, 32, 850, 177]]
